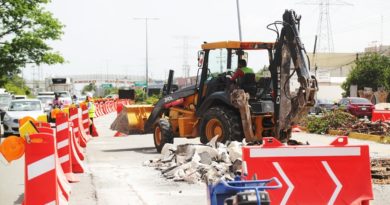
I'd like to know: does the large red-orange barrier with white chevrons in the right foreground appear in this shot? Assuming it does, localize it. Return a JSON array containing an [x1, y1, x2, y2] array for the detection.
[[242, 137, 373, 204]]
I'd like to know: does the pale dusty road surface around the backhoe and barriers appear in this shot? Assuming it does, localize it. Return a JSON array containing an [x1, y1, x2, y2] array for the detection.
[[0, 113, 390, 205]]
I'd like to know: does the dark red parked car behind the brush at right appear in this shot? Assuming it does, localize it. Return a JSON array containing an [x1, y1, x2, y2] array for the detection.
[[338, 97, 375, 118]]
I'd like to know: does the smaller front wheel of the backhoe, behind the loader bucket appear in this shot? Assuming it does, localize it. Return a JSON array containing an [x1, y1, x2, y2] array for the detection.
[[153, 119, 173, 153]]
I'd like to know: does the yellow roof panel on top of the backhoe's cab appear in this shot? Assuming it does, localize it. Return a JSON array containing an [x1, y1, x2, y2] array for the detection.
[[202, 41, 275, 50]]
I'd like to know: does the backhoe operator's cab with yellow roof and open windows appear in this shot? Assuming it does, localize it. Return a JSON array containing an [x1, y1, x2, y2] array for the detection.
[[198, 41, 274, 114]]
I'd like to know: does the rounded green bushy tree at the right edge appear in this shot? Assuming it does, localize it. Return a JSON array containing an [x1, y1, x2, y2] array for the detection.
[[341, 53, 390, 96]]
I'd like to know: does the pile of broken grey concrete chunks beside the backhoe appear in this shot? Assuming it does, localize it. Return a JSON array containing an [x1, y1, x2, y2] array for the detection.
[[144, 137, 243, 183]]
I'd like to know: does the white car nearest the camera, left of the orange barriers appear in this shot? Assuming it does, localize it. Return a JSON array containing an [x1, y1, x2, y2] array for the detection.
[[3, 99, 45, 135]]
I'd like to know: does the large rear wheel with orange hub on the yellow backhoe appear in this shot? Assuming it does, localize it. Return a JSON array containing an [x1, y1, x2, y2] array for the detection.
[[200, 107, 242, 144]]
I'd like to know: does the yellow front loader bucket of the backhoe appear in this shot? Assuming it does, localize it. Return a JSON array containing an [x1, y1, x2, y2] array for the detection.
[[125, 105, 154, 132]]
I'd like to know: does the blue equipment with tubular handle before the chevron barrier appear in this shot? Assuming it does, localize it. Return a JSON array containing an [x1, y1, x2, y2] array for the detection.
[[208, 177, 282, 205]]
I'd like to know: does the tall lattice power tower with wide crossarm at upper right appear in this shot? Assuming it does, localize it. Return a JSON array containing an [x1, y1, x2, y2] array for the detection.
[[297, 0, 353, 53]]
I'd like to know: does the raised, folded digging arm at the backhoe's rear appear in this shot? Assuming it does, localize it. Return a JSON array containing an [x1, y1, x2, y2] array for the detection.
[[270, 10, 318, 141]]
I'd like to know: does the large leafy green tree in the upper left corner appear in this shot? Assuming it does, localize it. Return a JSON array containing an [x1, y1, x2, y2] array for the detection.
[[0, 0, 64, 86]]
